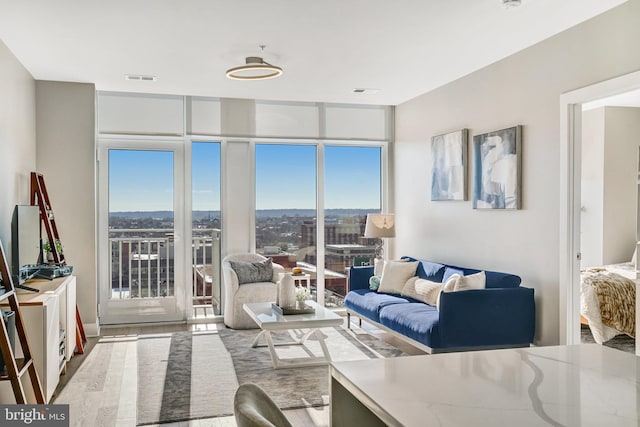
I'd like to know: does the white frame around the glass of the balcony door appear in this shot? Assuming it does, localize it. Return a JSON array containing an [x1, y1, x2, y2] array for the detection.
[[96, 136, 192, 324]]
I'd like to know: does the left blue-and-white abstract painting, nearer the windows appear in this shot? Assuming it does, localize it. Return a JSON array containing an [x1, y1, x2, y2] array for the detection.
[[431, 129, 468, 200]]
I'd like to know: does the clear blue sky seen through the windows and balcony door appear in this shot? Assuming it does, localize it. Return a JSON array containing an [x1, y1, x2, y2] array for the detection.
[[109, 142, 381, 212]]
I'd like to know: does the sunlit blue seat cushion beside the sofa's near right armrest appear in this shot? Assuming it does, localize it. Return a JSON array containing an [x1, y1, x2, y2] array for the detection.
[[379, 302, 441, 348]]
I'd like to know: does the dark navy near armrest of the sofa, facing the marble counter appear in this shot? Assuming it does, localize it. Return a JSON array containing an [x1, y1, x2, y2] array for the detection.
[[439, 286, 536, 347]]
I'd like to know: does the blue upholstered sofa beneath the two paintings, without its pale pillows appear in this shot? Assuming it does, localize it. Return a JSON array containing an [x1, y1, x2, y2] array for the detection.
[[345, 257, 535, 353]]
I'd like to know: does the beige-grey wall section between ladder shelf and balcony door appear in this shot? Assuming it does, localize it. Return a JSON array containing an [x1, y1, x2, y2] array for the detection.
[[36, 81, 97, 335]]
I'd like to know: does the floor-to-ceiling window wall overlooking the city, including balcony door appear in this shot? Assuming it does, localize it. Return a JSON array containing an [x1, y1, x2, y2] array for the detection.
[[96, 92, 393, 323]]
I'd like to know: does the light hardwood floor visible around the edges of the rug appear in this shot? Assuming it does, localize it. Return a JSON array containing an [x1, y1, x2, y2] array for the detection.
[[53, 318, 423, 427]]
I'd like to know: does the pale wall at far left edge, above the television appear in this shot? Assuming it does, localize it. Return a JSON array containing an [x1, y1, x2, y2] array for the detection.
[[0, 41, 36, 265]]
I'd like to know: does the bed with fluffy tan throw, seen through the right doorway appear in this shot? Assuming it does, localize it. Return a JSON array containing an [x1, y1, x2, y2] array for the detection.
[[580, 262, 638, 344]]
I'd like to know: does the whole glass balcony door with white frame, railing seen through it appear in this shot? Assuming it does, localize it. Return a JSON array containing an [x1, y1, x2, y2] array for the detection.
[[98, 141, 187, 324]]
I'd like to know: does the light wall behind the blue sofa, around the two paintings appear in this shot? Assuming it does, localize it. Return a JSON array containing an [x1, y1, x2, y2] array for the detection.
[[395, 0, 640, 344]]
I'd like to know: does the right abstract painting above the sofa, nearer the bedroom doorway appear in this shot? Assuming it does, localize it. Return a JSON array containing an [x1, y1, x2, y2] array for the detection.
[[473, 126, 522, 209]]
